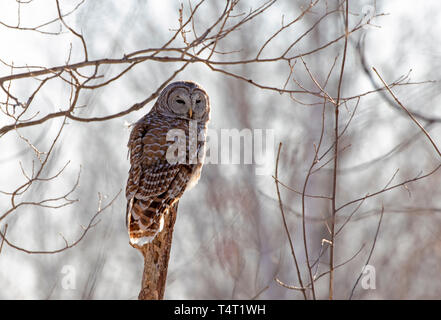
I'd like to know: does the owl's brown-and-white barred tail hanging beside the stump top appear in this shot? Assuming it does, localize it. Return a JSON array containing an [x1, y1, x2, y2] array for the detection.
[[126, 197, 177, 246]]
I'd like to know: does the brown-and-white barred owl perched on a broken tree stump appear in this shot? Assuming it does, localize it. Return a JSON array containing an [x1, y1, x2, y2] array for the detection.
[[126, 81, 210, 247]]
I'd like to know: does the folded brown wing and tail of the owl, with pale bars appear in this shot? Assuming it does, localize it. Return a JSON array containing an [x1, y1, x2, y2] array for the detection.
[[126, 117, 194, 245]]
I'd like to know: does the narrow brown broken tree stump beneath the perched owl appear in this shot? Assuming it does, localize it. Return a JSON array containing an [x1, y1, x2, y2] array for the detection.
[[137, 203, 178, 300]]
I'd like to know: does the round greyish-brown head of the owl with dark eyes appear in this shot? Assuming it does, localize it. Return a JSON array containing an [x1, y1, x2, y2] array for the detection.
[[153, 81, 210, 122]]
